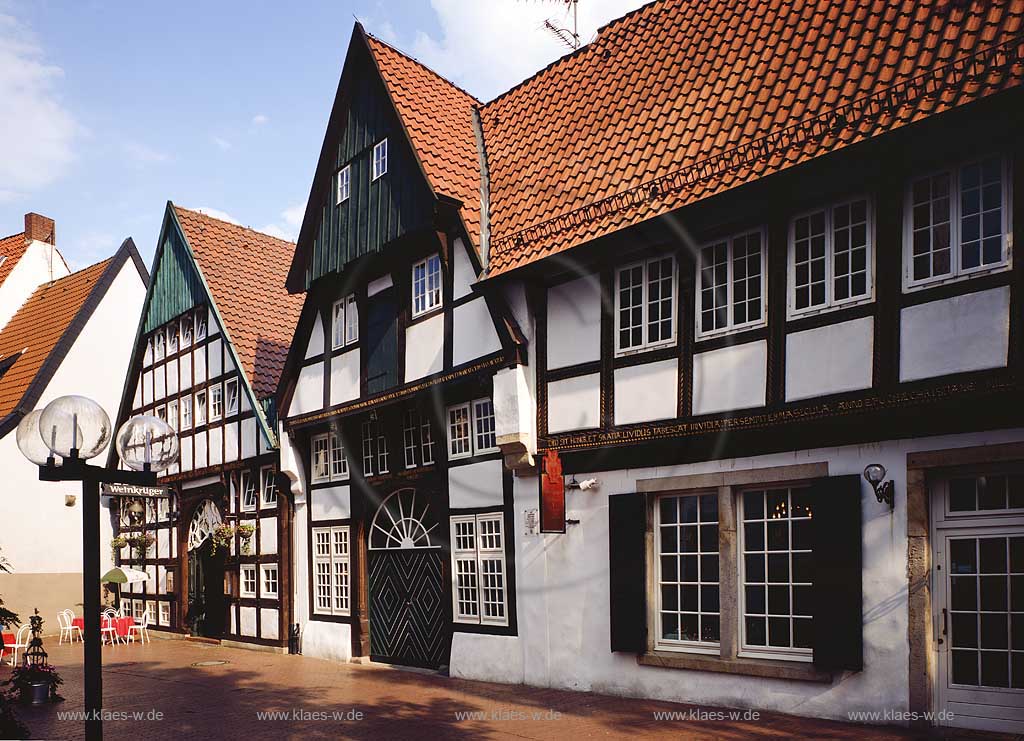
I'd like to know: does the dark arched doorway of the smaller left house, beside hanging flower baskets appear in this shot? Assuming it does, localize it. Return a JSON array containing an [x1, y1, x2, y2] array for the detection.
[[185, 499, 226, 638]]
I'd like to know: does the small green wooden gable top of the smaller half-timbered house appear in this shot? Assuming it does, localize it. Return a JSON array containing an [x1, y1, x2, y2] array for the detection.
[[142, 218, 207, 335]]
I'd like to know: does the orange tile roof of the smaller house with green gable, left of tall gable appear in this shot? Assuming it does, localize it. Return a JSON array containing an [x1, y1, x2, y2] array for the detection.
[[174, 206, 304, 398]]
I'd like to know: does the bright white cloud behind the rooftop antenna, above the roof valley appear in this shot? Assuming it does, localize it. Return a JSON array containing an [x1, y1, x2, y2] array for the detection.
[[367, 0, 648, 101]]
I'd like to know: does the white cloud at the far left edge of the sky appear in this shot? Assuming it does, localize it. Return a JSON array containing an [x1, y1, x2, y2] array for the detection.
[[0, 13, 79, 200]]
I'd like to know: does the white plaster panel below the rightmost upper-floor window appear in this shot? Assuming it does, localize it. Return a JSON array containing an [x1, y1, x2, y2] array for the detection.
[[899, 286, 1010, 381]]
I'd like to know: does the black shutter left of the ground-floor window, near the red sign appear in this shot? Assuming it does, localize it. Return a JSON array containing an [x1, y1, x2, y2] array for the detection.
[[608, 494, 647, 653]]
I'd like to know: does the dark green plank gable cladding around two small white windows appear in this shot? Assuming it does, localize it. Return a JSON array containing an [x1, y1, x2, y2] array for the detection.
[[305, 52, 434, 289]]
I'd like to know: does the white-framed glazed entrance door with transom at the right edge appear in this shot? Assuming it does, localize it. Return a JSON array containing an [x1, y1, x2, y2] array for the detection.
[[932, 472, 1024, 733]]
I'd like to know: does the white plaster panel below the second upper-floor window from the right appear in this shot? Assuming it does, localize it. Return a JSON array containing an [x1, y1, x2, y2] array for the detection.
[[785, 316, 874, 401]]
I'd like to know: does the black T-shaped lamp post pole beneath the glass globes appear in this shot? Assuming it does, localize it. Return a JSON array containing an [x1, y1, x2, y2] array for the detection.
[[39, 450, 157, 741]]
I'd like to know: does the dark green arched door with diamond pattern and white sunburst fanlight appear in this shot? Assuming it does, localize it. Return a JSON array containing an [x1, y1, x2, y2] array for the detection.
[[367, 489, 451, 668]]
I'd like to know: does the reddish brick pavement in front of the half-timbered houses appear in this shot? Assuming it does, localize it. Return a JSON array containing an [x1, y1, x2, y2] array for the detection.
[[0, 639, 999, 741]]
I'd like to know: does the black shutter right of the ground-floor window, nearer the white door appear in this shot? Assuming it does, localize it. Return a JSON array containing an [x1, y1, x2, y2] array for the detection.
[[811, 475, 864, 671]]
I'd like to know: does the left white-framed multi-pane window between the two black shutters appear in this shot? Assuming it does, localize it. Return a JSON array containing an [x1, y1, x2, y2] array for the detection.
[[655, 493, 721, 653]]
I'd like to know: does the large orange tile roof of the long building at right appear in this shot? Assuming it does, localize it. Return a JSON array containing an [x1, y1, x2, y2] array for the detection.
[[481, 0, 1024, 275]]
